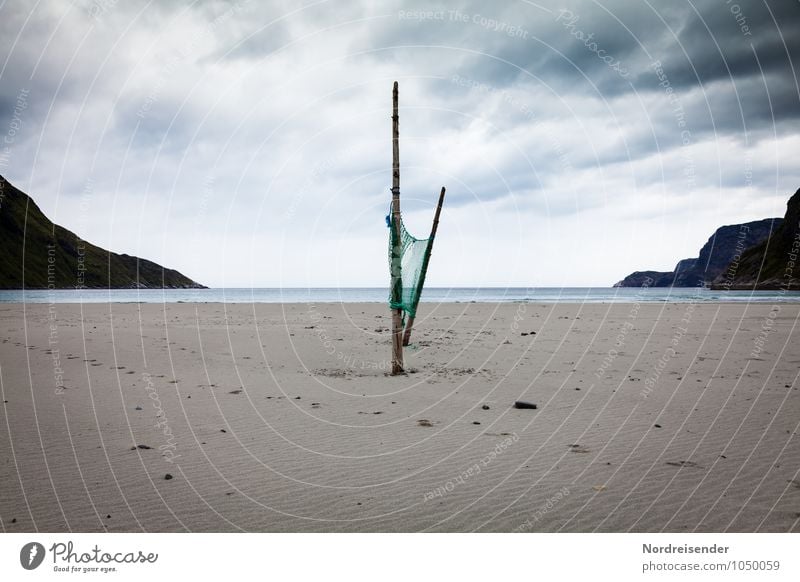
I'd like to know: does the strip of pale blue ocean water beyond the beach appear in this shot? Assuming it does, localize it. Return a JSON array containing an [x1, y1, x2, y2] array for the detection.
[[0, 287, 800, 303]]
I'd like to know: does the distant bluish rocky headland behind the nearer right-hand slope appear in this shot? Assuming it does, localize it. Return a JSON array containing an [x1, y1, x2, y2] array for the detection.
[[614, 218, 783, 287]]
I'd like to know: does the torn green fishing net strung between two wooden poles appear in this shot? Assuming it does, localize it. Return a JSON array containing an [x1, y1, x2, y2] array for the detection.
[[387, 213, 432, 317]]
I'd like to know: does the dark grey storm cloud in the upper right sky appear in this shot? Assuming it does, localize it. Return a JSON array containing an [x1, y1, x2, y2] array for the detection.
[[404, 1, 800, 138]]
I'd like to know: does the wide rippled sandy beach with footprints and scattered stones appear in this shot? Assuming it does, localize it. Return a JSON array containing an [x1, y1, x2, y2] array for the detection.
[[0, 303, 800, 532]]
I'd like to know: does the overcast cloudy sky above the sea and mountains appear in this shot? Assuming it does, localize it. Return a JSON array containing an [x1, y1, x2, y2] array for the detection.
[[0, 0, 800, 287]]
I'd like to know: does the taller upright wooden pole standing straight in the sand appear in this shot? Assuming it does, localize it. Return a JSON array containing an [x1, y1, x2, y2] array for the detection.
[[391, 81, 403, 376]]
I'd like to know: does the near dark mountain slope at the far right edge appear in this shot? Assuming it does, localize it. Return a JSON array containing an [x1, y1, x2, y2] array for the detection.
[[712, 190, 800, 291]]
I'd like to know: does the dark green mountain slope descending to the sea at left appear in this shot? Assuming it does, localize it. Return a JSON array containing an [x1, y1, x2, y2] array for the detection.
[[0, 176, 203, 289]]
